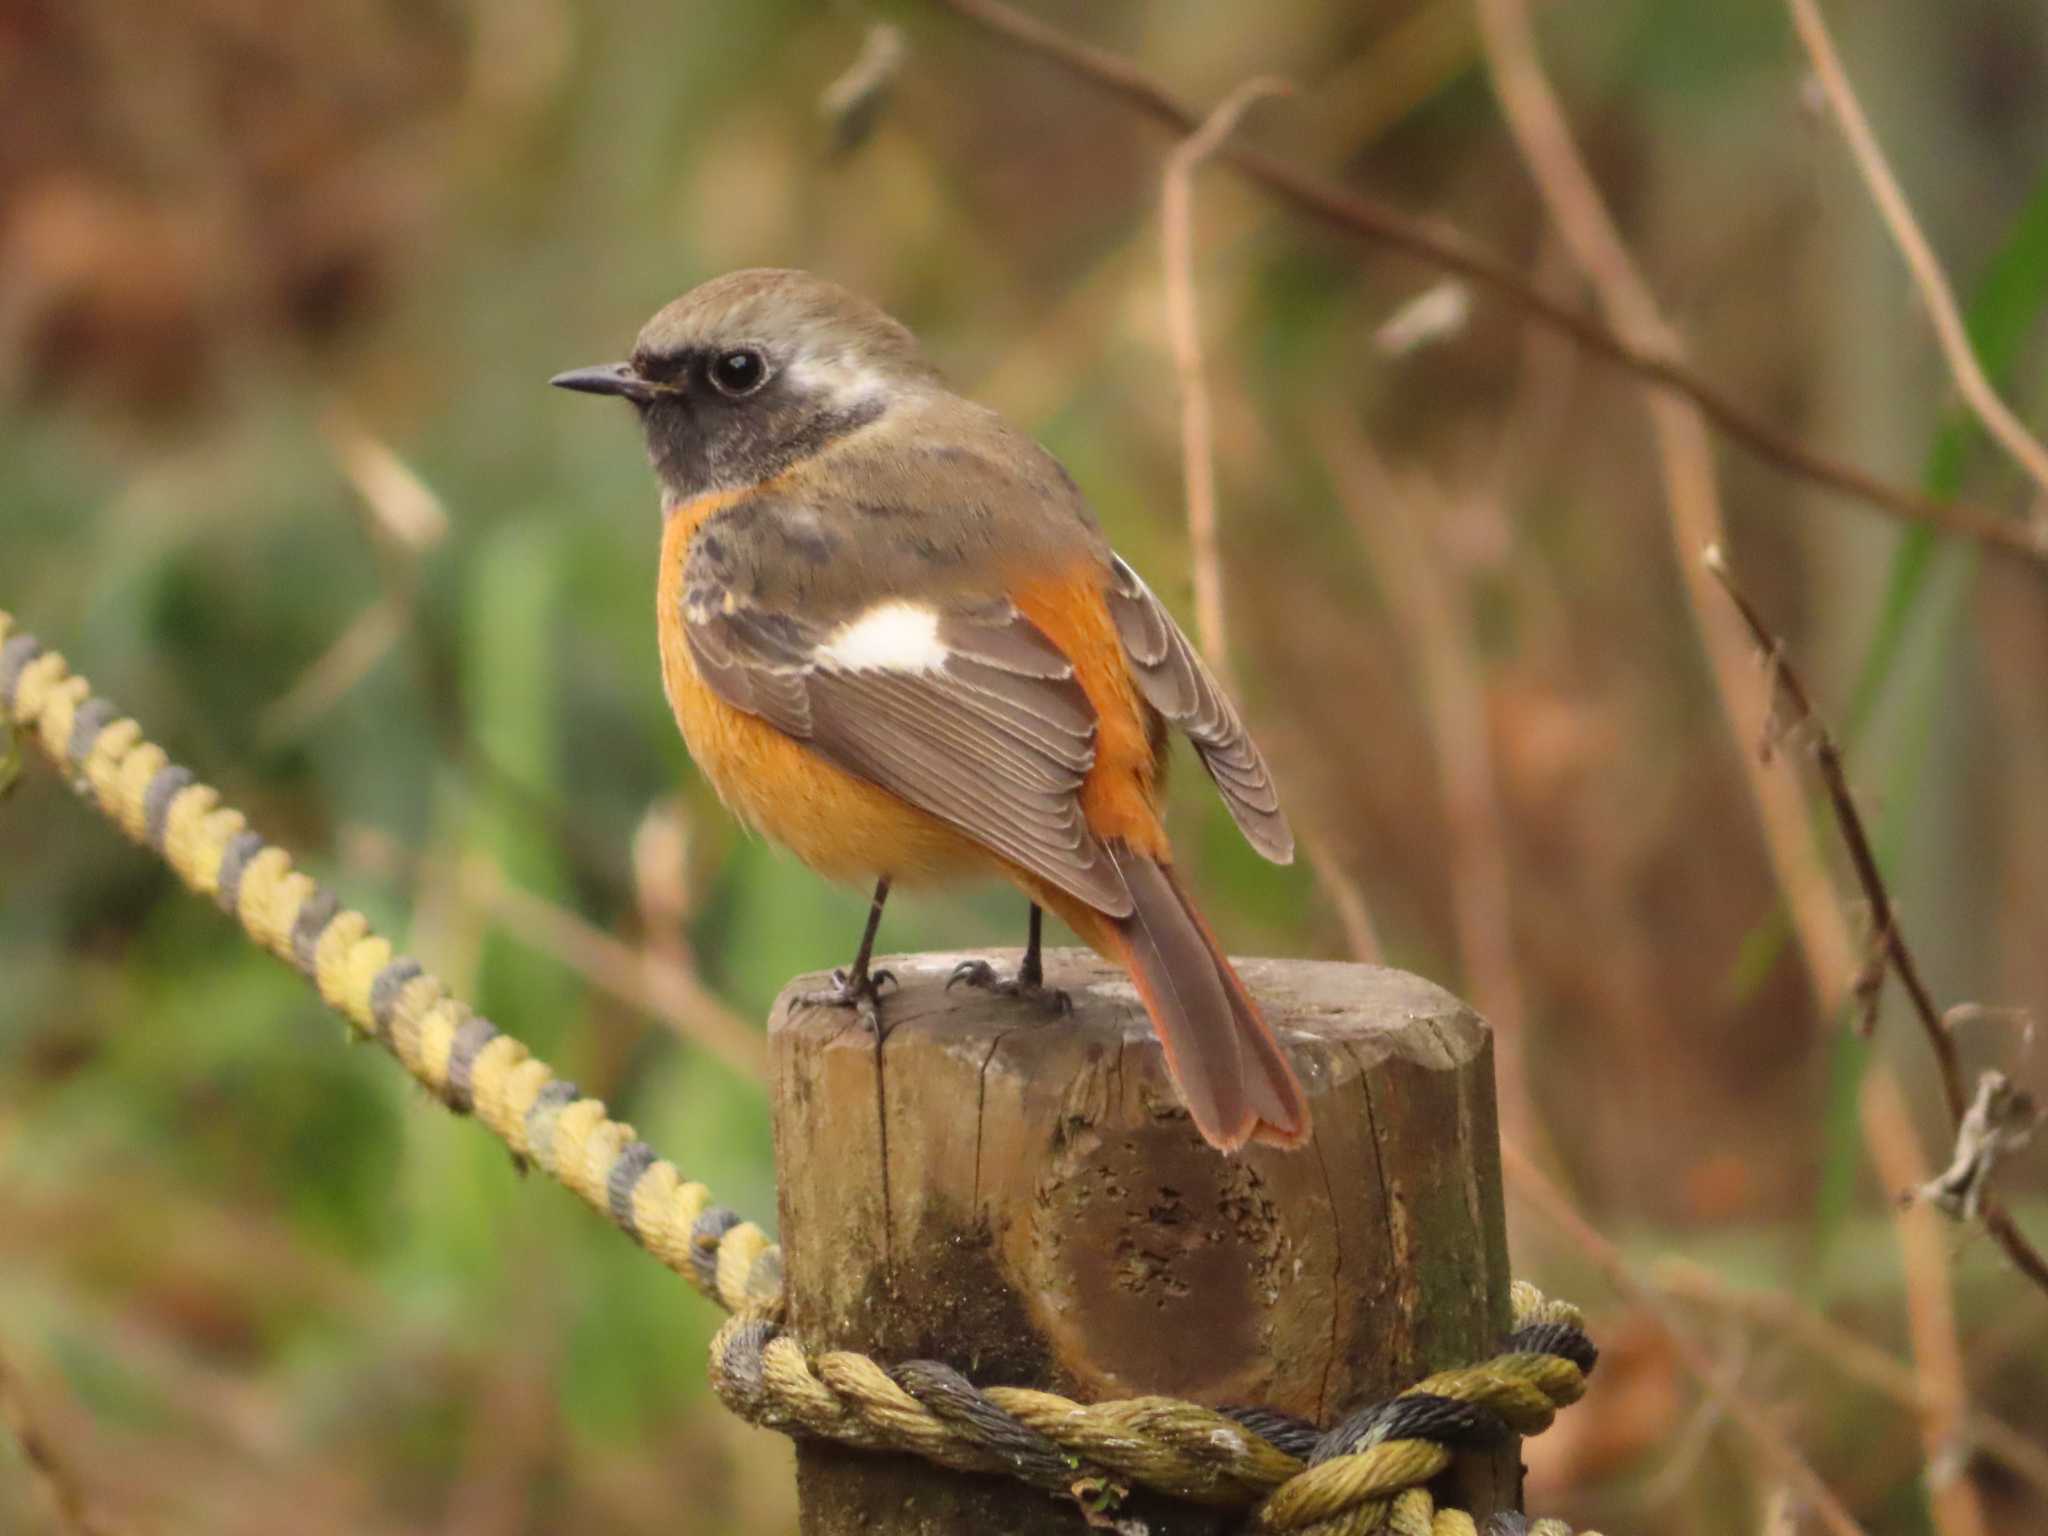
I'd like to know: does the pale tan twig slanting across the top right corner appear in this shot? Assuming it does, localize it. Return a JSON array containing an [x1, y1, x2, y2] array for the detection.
[[1786, 0, 2048, 496]]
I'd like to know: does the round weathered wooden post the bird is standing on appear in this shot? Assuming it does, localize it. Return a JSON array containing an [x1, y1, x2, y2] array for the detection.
[[770, 950, 1518, 1536]]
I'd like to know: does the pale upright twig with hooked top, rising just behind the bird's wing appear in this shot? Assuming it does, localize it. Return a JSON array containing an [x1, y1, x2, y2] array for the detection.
[[1159, 76, 1292, 692]]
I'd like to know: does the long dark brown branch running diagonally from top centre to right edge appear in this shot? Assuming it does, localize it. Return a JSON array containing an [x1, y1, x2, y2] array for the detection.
[[938, 0, 2048, 561]]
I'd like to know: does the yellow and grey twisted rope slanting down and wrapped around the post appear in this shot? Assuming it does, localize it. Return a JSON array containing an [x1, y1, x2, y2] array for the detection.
[[0, 610, 1597, 1536]]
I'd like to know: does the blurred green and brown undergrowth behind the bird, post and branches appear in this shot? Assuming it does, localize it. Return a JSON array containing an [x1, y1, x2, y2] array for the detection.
[[0, 0, 2048, 1536]]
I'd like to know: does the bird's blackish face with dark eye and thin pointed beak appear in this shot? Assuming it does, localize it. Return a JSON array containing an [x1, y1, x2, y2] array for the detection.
[[553, 342, 885, 502]]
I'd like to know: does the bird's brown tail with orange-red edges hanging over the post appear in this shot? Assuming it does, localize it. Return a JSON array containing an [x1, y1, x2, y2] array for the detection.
[[1108, 842, 1309, 1151]]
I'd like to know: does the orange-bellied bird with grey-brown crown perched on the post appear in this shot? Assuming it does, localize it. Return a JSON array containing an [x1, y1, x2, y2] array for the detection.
[[551, 268, 1309, 1153]]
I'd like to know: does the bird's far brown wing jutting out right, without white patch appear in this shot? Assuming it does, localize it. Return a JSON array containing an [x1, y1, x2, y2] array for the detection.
[[1110, 557, 1294, 864]]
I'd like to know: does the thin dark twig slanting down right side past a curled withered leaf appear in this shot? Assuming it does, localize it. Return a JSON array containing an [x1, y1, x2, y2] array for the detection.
[[1704, 545, 2048, 1292]]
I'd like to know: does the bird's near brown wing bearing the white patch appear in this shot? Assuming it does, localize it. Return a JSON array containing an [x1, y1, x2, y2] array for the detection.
[[684, 573, 1130, 918]]
